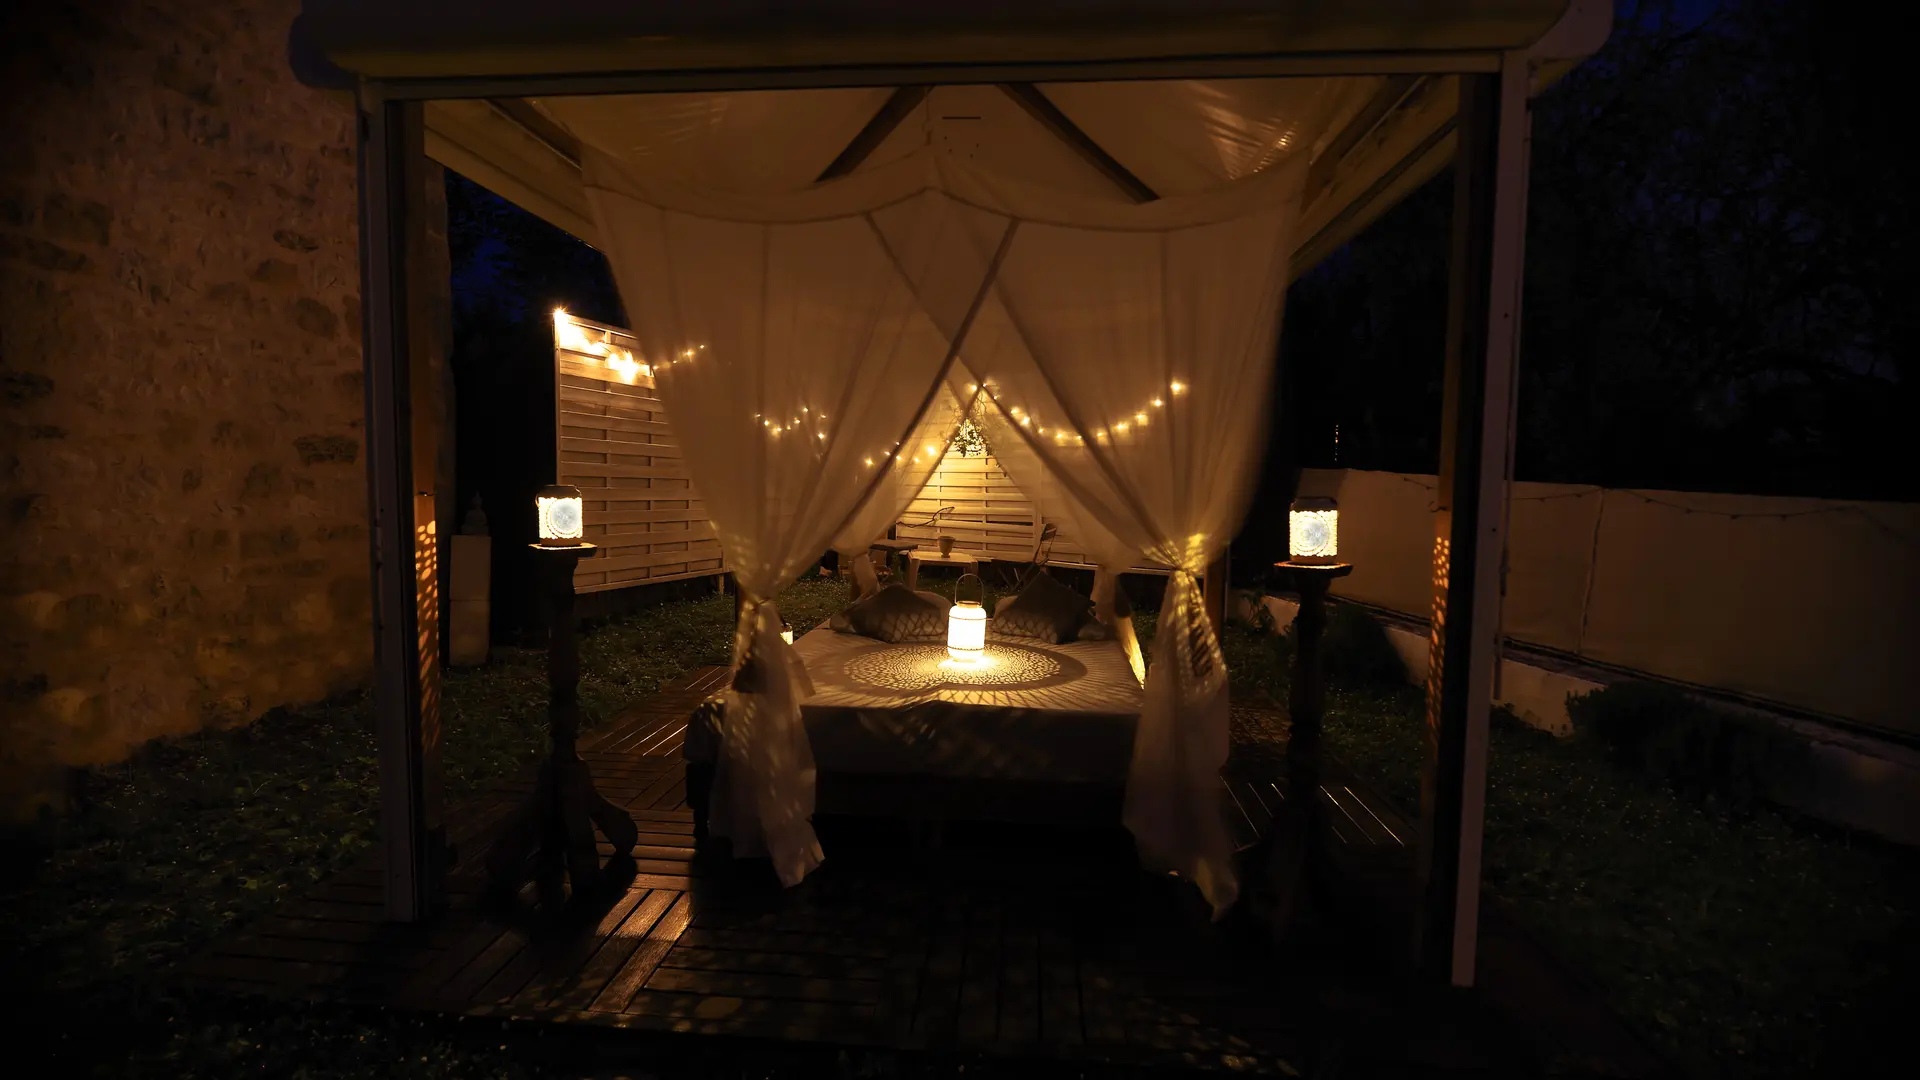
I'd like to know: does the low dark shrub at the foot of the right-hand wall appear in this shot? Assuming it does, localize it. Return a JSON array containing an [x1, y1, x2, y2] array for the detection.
[[1567, 680, 1807, 809]]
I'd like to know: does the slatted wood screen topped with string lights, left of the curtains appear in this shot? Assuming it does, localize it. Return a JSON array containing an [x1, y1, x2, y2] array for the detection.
[[553, 313, 726, 592]]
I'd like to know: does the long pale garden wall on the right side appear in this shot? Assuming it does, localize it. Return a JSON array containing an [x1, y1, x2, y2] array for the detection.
[[1274, 471, 1920, 732]]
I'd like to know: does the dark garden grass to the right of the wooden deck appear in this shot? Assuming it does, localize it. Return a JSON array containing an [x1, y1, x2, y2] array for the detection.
[[1223, 630, 1920, 1078]]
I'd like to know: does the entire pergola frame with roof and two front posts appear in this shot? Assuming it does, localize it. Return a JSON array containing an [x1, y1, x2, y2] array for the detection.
[[290, 0, 1611, 986]]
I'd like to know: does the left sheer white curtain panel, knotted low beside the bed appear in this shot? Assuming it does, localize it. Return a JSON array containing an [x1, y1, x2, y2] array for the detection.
[[586, 148, 987, 884]]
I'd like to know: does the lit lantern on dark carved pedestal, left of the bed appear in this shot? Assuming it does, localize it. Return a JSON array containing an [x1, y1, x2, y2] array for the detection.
[[488, 484, 639, 896]]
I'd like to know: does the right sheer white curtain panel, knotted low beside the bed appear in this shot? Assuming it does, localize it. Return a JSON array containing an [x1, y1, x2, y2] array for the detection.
[[898, 169, 1300, 915]]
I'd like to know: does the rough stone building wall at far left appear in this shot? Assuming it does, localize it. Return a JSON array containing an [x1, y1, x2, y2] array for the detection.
[[0, 0, 372, 813]]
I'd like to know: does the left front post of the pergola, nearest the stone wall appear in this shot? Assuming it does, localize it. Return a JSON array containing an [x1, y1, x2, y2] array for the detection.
[[359, 94, 447, 922]]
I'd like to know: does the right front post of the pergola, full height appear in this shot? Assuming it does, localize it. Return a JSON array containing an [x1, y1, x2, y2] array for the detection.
[[1415, 54, 1528, 988]]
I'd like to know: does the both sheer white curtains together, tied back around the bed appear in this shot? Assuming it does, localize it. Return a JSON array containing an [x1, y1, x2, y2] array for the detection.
[[586, 152, 1302, 899]]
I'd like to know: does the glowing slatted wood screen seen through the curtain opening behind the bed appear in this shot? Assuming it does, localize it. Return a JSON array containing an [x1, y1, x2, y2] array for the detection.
[[895, 454, 1167, 573]]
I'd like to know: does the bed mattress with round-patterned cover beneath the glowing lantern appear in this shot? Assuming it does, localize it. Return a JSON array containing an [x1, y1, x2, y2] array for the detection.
[[793, 626, 1144, 784]]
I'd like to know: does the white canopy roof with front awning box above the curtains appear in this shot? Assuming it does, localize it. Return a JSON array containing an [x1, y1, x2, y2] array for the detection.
[[397, 0, 1611, 275]]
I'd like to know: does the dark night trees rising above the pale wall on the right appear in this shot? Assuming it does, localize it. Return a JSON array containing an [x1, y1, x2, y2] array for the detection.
[[1283, 0, 1920, 500]]
